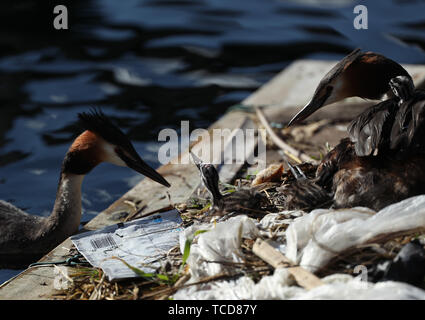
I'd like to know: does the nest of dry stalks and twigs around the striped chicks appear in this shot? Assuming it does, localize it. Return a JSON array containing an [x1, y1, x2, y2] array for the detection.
[[55, 118, 425, 300]]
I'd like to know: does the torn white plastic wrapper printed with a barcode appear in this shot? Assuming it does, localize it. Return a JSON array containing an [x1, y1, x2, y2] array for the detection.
[[71, 210, 182, 281]]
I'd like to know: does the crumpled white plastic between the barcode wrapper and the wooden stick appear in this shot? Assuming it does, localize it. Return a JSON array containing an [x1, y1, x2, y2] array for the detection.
[[180, 215, 258, 282]]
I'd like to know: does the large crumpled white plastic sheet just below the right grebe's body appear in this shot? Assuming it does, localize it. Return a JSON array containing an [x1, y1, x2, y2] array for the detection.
[[286, 195, 425, 272]]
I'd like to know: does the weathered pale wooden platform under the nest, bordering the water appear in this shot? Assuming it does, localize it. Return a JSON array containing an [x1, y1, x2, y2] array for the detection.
[[0, 60, 425, 300]]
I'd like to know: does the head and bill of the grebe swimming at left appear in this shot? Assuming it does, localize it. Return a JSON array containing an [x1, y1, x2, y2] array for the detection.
[[62, 110, 170, 187]]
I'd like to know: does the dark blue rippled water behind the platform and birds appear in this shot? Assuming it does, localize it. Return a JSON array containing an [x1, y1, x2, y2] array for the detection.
[[0, 0, 425, 283]]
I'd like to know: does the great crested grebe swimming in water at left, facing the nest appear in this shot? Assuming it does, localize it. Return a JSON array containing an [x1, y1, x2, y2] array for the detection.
[[0, 111, 170, 268]]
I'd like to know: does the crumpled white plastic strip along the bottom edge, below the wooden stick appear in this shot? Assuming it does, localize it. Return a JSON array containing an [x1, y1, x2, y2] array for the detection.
[[173, 268, 425, 300]]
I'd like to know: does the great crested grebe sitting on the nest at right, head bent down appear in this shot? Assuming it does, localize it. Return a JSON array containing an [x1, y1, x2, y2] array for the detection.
[[289, 50, 425, 210]]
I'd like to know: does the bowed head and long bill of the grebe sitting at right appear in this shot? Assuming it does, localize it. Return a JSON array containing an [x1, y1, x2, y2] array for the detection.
[[288, 49, 411, 126]]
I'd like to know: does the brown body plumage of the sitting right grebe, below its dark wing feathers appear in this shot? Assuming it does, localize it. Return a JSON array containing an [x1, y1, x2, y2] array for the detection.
[[315, 138, 425, 210]]
